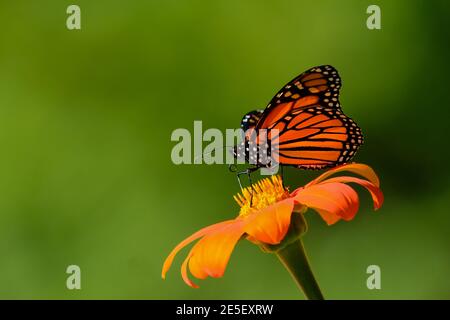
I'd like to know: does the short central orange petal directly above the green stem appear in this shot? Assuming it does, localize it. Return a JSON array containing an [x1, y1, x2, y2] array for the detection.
[[244, 198, 294, 244]]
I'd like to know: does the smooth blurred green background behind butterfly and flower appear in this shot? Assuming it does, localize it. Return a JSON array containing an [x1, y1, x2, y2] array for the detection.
[[0, 0, 450, 299]]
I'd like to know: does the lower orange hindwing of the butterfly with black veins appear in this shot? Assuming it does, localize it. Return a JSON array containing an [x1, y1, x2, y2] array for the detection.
[[272, 104, 363, 169]]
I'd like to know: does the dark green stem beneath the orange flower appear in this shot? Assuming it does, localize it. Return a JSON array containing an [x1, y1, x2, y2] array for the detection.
[[277, 239, 324, 300]]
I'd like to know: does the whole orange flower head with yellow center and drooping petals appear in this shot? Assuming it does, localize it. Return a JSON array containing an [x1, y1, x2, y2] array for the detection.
[[162, 164, 383, 288]]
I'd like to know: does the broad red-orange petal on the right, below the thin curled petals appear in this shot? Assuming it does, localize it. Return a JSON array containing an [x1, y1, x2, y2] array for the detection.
[[294, 181, 359, 225]]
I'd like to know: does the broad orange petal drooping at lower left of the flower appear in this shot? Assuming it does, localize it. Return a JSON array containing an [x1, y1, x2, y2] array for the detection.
[[181, 218, 245, 287]]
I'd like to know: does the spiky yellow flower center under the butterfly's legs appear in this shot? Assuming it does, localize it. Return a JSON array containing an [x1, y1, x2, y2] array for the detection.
[[234, 176, 289, 216]]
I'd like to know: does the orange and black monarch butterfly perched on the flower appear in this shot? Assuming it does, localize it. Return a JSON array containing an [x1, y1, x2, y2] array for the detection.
[[233, 65, 363, 174]]
